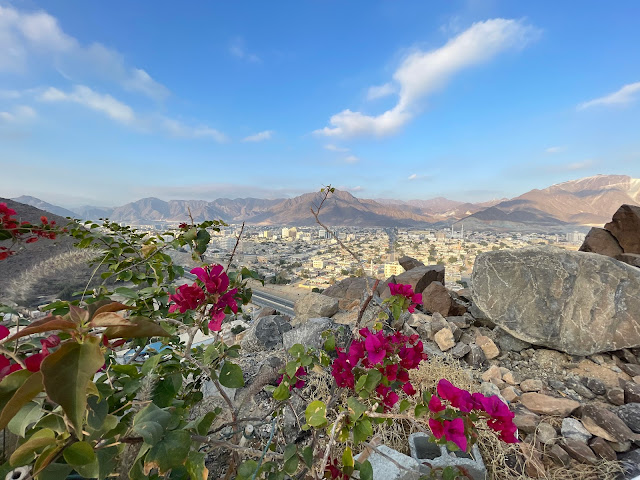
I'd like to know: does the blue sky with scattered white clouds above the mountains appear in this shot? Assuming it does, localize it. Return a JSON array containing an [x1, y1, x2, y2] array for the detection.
[[0, 0, 640, 207]]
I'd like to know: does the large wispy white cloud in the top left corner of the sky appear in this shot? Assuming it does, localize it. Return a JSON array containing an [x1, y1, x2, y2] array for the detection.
[[0, 6, 169, 100]]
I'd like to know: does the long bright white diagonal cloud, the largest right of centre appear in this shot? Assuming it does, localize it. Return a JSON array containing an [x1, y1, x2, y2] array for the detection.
[[315, 18, 538, 137]]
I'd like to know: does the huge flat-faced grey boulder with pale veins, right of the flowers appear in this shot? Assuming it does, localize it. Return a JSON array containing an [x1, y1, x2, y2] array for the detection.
[[472, 247, 640, 355]]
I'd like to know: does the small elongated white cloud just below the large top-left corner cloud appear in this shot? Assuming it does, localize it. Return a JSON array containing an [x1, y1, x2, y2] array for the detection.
[[40, 85, 136, 125]]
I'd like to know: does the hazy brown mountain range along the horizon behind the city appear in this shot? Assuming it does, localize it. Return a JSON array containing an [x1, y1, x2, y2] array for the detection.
[[14, 175, 640, 230]]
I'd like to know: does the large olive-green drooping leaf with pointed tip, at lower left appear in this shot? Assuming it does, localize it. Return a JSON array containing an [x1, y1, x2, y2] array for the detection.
[[40, 337, 104, 439]]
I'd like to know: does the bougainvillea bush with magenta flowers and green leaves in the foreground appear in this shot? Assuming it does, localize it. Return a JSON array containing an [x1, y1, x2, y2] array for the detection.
[[0, 201, 517, 480]]
